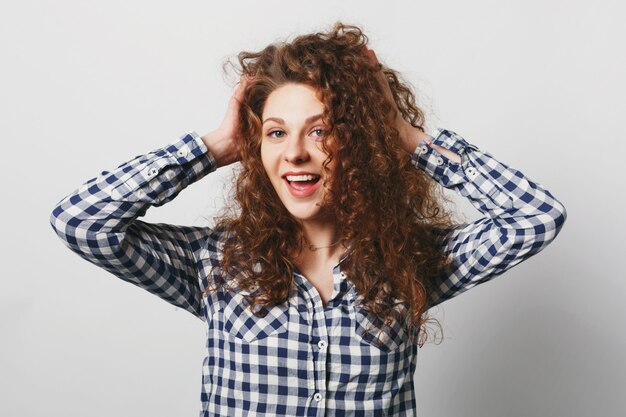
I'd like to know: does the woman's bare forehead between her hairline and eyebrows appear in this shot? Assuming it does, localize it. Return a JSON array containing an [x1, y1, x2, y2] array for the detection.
[[262, 84, 324, 122]]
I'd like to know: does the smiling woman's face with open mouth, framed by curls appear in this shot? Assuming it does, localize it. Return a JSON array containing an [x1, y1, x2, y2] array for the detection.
[[261, 84, 335, 221]]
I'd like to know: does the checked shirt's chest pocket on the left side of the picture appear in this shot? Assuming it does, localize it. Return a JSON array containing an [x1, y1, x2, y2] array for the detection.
[[211, 291, 291, 343]]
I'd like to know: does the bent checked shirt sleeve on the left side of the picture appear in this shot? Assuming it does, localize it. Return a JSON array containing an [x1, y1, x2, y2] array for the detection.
[[50, 132, 217, 320]]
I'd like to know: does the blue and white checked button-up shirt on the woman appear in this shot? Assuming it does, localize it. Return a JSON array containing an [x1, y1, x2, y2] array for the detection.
[[50, 129, 566, 417]]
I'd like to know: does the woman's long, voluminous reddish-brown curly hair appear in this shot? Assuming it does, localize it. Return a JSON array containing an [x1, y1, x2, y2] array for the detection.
[[207, 23, 452, 346]]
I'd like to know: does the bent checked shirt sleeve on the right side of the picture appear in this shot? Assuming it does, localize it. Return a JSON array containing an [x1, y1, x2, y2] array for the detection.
[[412, 129, 567, 308]]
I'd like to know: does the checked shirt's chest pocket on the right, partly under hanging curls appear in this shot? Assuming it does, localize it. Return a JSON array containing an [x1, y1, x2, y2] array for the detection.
[[353, 290, 410, 352]]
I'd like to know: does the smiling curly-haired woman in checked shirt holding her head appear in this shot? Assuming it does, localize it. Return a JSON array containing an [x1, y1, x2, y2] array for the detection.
[[51, 24, 566, 416]]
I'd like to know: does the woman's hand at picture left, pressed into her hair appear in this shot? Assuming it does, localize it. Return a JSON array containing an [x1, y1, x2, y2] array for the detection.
[[202, 76, 250, 167]]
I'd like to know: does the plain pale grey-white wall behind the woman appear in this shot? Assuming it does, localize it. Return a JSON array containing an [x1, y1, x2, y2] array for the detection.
[[0, 0, 626, 417]]
